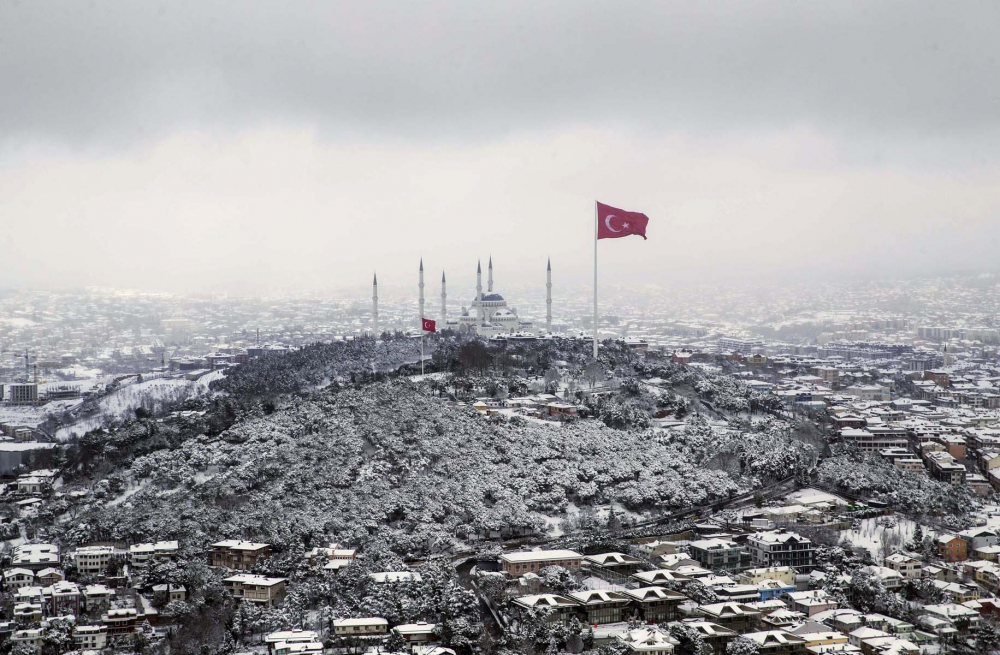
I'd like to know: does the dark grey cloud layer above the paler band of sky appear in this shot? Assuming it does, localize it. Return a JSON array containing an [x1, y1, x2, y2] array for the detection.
[[0, 0, 1000, 145]]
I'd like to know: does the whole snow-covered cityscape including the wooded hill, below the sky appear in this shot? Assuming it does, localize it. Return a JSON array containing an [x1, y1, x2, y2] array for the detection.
[[0, 272, 1000, 655]]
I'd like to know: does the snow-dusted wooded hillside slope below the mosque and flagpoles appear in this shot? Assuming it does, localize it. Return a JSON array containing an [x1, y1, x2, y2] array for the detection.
[[66, 380, 811, 556]]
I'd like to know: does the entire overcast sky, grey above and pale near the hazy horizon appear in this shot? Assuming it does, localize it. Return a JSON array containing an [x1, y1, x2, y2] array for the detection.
[[0, 0, 1000, 295]]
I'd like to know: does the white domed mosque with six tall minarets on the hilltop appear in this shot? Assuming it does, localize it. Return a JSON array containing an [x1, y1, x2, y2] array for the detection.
[[372, 257, 552, 337]]
